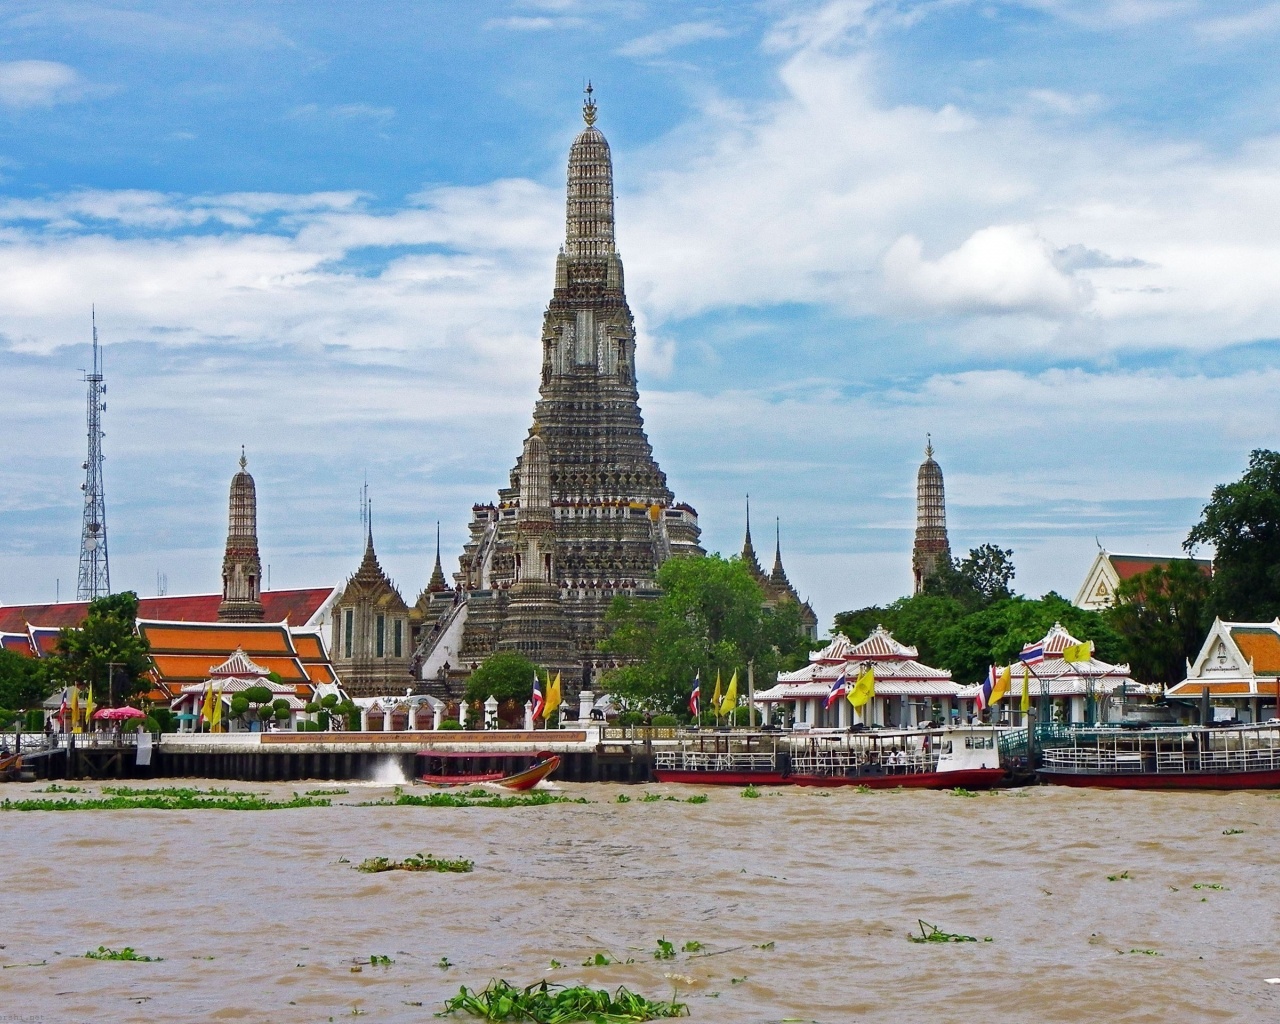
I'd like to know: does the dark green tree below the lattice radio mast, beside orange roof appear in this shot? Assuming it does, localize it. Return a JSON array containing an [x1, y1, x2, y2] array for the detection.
[[49, 591, 151, 705]]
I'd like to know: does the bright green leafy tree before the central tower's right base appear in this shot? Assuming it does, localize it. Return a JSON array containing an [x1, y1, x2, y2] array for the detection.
[[600, 554, 812, 714]]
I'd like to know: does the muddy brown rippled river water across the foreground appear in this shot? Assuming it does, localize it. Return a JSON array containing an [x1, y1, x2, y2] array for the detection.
[[0, 782, 1280, 1024]]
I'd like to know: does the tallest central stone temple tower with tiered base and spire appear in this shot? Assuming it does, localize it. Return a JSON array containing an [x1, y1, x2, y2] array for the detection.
[[416, 87, 703, 695]]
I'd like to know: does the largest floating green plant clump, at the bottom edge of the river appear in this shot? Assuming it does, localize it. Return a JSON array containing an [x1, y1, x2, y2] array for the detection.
[[436, 980, 689, 1024]]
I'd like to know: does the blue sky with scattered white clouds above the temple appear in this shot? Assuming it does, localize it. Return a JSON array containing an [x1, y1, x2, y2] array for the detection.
[[0, 0, 1280, 627]]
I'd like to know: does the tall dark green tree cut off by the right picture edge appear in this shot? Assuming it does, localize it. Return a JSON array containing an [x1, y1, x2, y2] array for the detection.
[[1183, 448, 1280, 622]]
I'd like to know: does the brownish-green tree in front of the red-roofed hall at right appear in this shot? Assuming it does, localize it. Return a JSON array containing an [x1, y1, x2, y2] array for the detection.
[[1103, 558, 1213, 686]]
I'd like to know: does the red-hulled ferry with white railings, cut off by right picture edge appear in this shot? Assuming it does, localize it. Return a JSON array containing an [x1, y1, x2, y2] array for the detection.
[[1038, 724, 1280, 790]]
